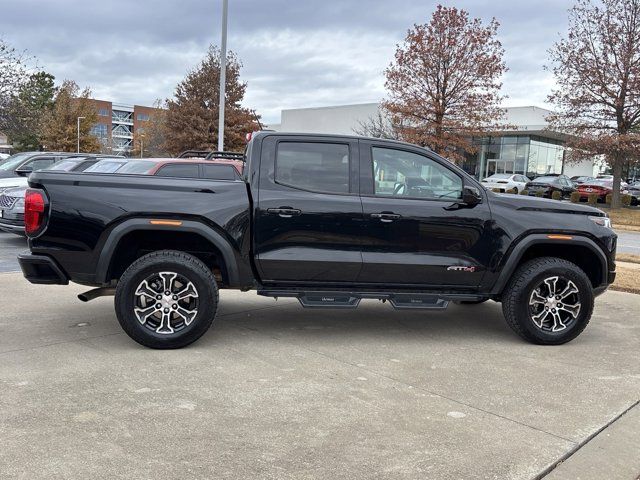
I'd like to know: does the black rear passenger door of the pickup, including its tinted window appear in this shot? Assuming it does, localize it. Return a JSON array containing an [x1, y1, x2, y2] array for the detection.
[[254, 135, 363, 284]]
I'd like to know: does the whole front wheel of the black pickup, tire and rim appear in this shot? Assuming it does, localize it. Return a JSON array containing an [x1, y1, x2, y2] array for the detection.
[[502, 257, 594, 345]]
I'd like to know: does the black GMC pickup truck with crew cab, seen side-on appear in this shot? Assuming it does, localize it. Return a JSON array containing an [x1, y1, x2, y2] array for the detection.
[[19, 132, 616, 348]]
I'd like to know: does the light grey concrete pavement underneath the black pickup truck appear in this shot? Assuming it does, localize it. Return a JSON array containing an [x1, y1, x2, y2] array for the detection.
[[0, 274, 640, 480]]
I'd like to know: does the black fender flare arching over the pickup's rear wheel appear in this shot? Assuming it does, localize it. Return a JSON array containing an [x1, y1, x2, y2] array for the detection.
[[96, 218, 240, 285]]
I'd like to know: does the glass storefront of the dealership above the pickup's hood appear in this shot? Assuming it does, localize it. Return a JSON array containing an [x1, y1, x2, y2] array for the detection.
[[463, 135, 565, 180]]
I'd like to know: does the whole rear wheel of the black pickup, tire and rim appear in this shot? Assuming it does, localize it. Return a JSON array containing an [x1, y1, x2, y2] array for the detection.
[[115, 250, 218, 349]]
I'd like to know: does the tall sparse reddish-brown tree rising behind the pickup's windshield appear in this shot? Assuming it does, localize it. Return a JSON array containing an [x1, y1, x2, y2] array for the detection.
[[383, 5, 507, 160]]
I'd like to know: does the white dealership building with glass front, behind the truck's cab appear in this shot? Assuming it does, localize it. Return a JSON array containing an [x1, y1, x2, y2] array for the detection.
[[270, 103, 598, 179]]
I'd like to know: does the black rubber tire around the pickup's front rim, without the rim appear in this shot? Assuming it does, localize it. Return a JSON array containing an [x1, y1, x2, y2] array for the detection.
[[502, 257, 594, 345]]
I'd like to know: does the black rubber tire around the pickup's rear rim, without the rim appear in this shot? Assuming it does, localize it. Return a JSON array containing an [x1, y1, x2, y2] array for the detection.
[[115, 250, 218, 349]]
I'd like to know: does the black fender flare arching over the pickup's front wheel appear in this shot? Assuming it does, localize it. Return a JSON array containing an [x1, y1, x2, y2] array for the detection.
[[491, 233, 608, 295]]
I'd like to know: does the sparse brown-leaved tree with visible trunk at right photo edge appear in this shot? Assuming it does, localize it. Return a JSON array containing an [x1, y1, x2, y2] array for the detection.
[[549, 0, 640, 208]]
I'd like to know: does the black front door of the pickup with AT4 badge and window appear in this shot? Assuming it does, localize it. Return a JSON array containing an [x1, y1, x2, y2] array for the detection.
[[358, 141, 496, 289]]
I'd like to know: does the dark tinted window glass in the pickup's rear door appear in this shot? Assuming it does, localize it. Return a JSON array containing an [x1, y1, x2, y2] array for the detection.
[[275, 142, 349, 193]]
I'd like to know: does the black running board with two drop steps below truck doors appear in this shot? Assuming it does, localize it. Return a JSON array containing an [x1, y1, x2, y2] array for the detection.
[[258, 290, 449, 310]]
